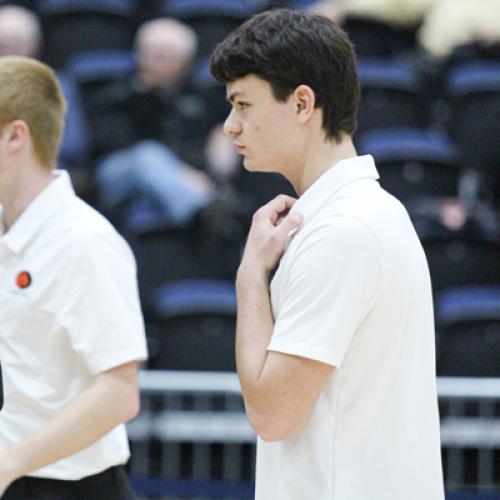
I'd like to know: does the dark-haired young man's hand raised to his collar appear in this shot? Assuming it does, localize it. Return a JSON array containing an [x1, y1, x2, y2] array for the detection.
[[241, 194, 304, 274]]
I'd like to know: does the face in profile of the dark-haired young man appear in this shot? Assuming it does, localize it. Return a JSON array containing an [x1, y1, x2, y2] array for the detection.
[[224, 75, 296, 174]]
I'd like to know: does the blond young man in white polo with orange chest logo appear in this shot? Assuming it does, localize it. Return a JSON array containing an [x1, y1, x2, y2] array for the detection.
[[0, 57, 146, 500]]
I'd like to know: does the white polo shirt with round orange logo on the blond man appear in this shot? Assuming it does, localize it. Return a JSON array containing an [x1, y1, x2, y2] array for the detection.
[[0, 171, 146, 480]]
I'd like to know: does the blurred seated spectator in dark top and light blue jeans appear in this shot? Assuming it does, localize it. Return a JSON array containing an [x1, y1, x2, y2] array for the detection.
[[92, 18, 242, 228]]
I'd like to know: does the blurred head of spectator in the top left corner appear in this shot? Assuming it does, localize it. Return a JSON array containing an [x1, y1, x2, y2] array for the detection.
[[0, 5, 42, 58]]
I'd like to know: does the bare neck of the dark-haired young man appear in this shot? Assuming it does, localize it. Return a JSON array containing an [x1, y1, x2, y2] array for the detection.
[[290, 135, 357, 196]]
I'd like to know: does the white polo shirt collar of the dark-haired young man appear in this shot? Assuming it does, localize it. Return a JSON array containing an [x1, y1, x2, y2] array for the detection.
[[291, 155, 379, 223]]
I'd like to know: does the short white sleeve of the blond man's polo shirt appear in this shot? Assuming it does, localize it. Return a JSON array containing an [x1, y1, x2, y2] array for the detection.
[[57, 232, 147, 374]]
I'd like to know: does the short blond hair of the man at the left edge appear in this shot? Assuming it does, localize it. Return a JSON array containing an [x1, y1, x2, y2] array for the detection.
[[0, 56, 66, 169]]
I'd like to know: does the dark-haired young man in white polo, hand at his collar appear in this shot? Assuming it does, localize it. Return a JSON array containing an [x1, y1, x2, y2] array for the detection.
[[211, 10, 444, 500]]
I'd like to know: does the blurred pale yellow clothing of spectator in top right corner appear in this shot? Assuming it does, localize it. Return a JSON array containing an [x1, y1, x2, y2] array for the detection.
[[419, 0, 500, 58]]
